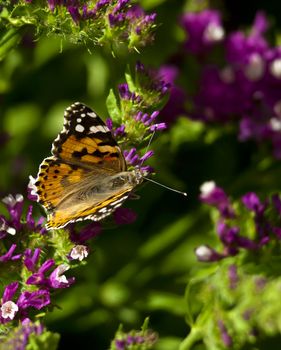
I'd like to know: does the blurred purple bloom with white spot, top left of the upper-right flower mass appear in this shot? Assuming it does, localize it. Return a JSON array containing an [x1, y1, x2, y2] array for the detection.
[[181, 9, 224, 55]]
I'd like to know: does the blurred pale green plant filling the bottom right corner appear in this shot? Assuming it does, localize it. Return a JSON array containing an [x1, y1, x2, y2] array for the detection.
[[180, 258, 281, 350]]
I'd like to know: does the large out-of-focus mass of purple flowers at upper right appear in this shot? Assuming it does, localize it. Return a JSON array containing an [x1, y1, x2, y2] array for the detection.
[[170, 9, 281, 159]]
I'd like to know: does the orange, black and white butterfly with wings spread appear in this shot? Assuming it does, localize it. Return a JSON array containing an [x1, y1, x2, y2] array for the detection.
[[35, 102, 144, 229]]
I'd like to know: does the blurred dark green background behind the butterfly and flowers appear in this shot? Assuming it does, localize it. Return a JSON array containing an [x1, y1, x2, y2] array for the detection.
[[0, 0, 281, 350]]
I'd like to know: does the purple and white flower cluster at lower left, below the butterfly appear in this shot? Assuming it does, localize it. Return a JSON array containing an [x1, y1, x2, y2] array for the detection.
[[0, 194, 92, 324]]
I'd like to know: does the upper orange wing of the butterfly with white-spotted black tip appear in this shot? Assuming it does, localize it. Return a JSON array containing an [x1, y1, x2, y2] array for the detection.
[[52, 102, 126, 172]]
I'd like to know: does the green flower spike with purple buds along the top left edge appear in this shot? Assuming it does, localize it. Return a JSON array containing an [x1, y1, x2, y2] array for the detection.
[[7, 0, 156, 50]]
